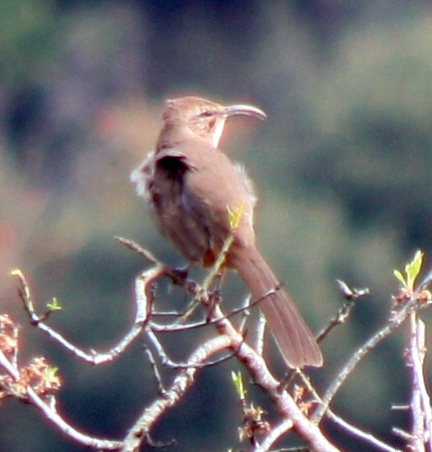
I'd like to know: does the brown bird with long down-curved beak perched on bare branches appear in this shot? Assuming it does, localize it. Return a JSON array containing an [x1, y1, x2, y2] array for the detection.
[[131, 97, 323, 367]]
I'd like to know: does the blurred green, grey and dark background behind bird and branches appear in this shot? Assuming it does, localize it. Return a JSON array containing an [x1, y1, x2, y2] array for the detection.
[[0, 0, 432, 451]]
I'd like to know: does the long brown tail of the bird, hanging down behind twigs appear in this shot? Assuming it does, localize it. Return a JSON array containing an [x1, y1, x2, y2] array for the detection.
[[230, 248, 323, 368]]
